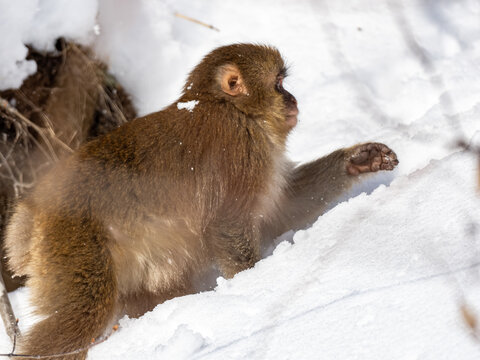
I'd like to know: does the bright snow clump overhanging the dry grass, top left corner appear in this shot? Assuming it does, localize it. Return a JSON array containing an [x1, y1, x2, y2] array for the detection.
[[0, 0, 98, 90]]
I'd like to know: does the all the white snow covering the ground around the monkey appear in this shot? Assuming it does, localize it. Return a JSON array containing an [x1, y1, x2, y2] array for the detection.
[[0, 0, 480, 360]]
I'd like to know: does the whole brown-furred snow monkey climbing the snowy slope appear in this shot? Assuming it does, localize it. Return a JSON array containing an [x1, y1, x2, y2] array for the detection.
[[6, 44, 398, 360]]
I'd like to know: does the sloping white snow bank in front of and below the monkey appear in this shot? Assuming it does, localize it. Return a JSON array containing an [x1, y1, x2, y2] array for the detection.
[[89, 153, 480, 359]]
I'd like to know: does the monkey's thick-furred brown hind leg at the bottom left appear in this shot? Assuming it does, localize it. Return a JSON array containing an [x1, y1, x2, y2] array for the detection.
[[19, 219, 116, 360]]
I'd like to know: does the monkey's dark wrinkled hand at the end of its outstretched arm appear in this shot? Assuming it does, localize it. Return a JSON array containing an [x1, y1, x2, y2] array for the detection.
[[346, 143, 398, 175]]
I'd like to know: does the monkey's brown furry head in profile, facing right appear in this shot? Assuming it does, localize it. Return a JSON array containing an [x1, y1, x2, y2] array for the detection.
[[184, 44, 298, 143]]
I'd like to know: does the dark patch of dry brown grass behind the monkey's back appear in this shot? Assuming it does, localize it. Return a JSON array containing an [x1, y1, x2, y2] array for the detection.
[[0, 39, 136, 290]]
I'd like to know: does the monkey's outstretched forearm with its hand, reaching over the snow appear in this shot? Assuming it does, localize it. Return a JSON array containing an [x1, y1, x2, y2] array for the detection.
[[262, 143, 398, 241]]
